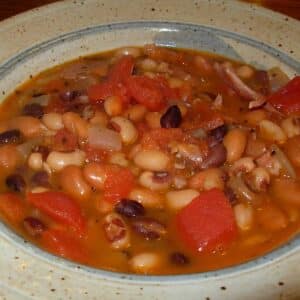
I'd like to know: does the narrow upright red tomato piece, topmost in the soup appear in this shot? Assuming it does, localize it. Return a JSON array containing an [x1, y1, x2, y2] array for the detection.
[[108, 55, 134, 83]]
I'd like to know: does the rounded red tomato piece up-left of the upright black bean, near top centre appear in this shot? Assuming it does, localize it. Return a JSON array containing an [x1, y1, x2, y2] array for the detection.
[[126, 76, 165, 111]]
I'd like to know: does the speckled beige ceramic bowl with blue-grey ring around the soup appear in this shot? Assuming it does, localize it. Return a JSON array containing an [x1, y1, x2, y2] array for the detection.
[[0, 0, 300, 300]]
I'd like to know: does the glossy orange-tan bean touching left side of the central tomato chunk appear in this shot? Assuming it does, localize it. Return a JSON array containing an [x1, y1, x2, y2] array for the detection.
[[83, 162, 107, 190]]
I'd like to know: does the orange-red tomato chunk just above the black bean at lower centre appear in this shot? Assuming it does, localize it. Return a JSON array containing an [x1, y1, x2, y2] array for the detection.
[[104, 166, 134, 203]]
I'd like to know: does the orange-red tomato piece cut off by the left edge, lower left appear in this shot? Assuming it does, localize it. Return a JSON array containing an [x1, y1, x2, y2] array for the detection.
[[0, 193, 25, 224]]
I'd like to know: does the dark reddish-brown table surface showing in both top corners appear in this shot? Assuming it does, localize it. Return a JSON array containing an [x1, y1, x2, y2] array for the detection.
[[0, 0, 300, 20]]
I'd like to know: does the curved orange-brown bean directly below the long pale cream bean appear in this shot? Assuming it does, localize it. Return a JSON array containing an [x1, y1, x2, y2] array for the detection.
[[59, 165, 92, 200]]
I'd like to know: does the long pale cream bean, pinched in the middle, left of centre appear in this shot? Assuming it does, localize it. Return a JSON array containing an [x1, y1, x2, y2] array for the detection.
[[46, 150, 85, 172]]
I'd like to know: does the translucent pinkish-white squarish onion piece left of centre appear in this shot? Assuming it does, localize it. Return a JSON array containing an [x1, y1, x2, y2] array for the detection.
[[88, 125, 122, 151]]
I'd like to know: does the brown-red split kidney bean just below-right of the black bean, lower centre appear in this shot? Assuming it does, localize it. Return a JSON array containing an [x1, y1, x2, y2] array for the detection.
[[132, 217, 167, 240]]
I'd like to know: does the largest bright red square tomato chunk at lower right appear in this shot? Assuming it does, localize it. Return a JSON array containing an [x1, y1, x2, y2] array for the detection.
[[176, 189, 238, 252]]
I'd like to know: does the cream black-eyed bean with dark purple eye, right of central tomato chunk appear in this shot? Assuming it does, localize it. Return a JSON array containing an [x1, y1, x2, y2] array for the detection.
[[139, 171, 171, 191]]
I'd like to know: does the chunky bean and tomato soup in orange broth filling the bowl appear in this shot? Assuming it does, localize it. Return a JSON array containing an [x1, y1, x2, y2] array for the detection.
[[0, 45, 300, 274]]
